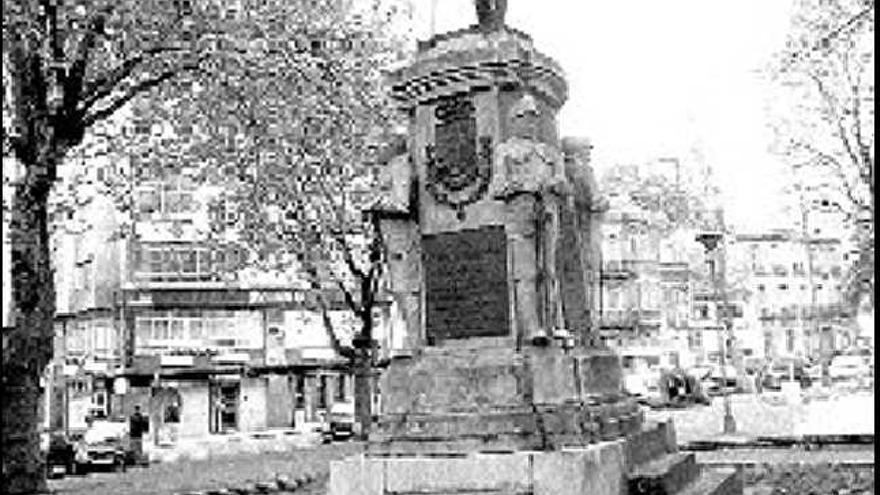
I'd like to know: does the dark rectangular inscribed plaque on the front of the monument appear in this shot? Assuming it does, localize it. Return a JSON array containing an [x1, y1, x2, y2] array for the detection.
[[422, 226, 510, 339]]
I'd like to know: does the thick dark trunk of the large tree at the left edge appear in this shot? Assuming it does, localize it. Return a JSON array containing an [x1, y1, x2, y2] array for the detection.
[[0, 176, 55, 494]]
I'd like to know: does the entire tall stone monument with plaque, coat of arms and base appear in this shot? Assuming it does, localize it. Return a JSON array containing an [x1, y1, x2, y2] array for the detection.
[[330, 4, 741, 495]]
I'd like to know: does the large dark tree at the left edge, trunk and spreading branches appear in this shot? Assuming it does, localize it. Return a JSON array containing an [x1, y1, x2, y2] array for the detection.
[[0, 0, 213, 493]]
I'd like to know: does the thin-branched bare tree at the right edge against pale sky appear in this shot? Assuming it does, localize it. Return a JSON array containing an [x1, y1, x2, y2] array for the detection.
[[769, 0, 875, 306]]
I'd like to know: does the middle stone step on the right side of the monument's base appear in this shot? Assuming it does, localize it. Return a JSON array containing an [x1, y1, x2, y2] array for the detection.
[[628, 452, 700, 495]]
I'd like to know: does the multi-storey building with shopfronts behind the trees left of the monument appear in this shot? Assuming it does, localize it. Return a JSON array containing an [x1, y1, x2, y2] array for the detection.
[[50, 156, 393, 444]]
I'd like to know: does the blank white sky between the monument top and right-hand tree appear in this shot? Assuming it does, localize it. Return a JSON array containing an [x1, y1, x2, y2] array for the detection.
[[413, 0, 792, 228]]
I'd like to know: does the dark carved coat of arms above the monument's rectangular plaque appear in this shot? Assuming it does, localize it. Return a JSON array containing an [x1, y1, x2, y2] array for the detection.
[[425, 96, 492, 216]]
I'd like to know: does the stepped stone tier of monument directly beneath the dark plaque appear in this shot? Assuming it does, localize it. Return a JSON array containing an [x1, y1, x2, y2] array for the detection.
[[368, 342, 643, 454]]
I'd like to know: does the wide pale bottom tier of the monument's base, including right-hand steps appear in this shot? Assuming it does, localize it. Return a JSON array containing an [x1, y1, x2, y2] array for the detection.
[[329, 423, 743, 495]]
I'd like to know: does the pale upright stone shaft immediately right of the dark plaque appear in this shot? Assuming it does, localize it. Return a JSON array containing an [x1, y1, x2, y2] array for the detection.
[[506, 194, 545, 342]]
